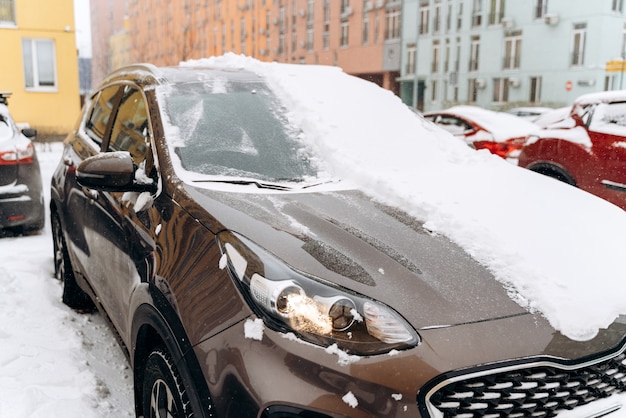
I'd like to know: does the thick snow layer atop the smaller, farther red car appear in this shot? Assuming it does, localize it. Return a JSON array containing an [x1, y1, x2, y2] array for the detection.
[[426, 105, 537, 142]]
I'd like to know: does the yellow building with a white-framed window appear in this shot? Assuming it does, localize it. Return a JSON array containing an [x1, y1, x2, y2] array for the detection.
[[0, 0, 80, 135]]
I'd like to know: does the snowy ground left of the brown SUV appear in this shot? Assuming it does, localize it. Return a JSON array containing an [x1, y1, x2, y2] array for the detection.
[[0, 143, 134, 418]]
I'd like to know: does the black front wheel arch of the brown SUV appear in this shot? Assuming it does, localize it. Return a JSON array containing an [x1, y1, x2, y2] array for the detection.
[[130, 285, 215, 417]]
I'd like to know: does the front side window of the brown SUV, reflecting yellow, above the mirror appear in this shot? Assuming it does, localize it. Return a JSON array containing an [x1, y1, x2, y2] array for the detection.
[[108, 86, 150, 169]]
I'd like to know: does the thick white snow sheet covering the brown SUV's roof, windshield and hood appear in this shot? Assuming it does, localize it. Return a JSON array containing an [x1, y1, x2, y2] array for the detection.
[[177, 54, 626, 340]]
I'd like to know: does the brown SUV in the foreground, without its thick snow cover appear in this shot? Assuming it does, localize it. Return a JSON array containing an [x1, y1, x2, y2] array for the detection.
[[50, 64, 626, 418]]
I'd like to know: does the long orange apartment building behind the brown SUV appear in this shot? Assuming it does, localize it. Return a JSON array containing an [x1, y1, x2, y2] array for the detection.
[[109, 0, 402, 93]]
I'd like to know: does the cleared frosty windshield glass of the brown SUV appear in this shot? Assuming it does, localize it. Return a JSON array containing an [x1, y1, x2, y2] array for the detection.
[[165, 78, 315, 182]]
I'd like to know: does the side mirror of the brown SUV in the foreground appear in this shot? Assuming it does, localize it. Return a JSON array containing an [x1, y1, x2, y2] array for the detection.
[[76, 151, 156, 193]]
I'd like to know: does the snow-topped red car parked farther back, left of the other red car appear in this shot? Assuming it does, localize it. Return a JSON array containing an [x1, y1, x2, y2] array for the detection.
[[424, 106, 538, 158]]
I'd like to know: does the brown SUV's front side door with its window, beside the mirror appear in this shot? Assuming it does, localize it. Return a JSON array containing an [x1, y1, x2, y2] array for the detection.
[[83, 85, 158, 338]]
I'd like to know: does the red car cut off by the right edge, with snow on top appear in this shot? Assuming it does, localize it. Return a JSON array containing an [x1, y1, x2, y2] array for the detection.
[[519, 90, 626, 209]]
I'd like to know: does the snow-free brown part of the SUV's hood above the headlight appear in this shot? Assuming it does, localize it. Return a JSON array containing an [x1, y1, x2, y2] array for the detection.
[[186, 186, 527, 329]]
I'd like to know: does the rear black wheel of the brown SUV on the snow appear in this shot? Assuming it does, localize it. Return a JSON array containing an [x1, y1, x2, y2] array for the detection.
[[51, 213, 95, 312]]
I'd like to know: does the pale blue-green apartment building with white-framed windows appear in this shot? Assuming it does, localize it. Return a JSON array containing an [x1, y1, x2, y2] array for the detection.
[[399, 0, 626, 111]]
